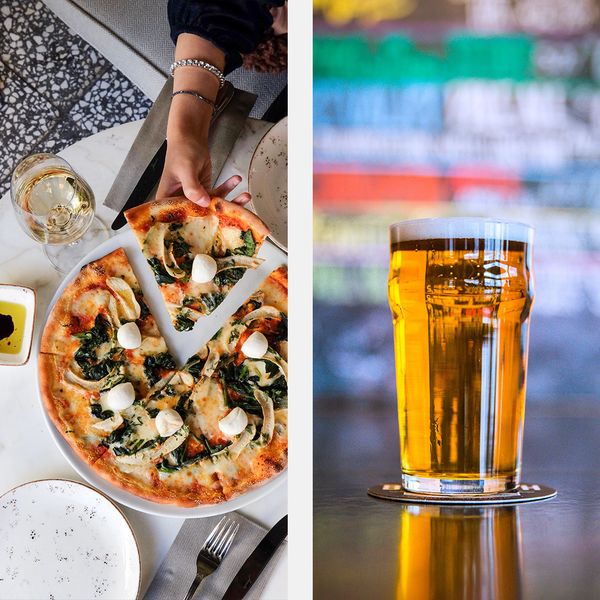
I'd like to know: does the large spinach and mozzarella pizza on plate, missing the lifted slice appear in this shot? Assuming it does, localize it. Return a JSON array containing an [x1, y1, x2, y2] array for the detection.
[[39, 249, 287, 506]]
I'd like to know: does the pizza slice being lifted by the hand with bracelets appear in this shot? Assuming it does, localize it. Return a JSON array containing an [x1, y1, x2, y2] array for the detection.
[[125, 197, 269, 331]]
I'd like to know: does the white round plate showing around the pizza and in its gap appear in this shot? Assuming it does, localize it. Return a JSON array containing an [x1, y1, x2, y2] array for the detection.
[[36, 227, 287, 518]]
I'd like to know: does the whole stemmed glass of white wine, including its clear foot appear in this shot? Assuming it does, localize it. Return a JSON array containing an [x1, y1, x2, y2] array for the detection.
[[10, 153, 109, 273]]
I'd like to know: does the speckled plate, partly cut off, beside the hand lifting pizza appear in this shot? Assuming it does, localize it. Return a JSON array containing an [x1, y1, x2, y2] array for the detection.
[[248, 117, 287, 251]]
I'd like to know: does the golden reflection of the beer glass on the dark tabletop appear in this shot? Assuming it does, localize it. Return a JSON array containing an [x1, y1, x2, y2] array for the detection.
[[396, 505, 522, 600]]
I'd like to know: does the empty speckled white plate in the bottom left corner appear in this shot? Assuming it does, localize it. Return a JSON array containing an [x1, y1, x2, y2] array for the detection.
[[0, 479, 141, 600]]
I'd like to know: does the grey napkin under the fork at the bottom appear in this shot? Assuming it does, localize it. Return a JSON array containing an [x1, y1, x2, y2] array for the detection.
[[144, 513, 287, 600]]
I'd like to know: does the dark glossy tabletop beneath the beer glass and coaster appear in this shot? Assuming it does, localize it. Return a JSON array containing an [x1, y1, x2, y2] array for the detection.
[[314, 398, 600, 600]]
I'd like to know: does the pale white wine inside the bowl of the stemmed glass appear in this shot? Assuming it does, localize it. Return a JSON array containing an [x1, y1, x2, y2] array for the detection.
[[14, 165, 95, 244]]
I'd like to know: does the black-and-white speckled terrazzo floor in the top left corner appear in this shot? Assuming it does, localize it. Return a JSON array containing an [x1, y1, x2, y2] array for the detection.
[[0, 0, 152, 195]]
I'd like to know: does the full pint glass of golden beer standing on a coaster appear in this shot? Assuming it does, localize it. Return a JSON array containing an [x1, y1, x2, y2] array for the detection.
[[389, 218, 533, 494]]
